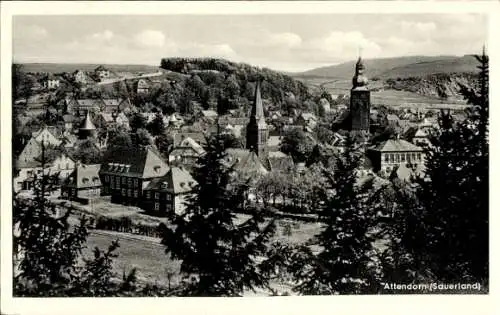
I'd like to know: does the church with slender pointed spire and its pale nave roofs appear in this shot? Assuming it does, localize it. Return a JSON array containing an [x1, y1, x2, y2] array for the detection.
[[226, 81, 294, 178]]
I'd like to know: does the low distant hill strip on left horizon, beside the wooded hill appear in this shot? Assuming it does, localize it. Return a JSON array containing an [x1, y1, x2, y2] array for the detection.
[[20, 63, 158, 73]]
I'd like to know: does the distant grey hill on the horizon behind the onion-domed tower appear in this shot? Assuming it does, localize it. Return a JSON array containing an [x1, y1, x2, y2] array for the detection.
[[293, 55, 477, 80]]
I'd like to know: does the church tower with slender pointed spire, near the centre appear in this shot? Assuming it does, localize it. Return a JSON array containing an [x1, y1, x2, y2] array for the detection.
[[246, 80, 269, 157]]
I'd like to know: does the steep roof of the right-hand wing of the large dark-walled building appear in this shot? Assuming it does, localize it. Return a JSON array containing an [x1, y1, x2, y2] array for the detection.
[[146, 167, 197, 195]]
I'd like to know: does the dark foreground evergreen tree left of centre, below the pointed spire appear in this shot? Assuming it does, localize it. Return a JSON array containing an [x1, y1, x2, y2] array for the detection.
[[162, 136, 275, 296]]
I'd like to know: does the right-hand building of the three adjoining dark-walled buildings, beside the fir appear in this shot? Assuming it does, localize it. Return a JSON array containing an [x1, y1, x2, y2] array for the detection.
[[143, 167, 197, 216]]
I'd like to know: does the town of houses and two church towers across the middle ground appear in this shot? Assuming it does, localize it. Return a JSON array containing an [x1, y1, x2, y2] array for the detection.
[[13, 58, 448, 211]]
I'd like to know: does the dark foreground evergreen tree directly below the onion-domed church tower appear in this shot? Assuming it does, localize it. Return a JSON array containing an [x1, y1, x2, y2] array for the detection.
[[289, 137, 376, 294]]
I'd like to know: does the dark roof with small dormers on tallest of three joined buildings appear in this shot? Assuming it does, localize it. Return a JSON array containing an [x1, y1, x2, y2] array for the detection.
[[101, 147, 168, 178]]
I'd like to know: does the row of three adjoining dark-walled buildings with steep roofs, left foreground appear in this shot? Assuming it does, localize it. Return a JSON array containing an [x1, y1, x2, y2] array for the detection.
[[61, 147, 197, 215]]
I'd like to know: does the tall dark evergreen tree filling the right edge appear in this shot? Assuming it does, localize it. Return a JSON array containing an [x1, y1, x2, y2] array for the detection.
[[386, 48, 489, 281]]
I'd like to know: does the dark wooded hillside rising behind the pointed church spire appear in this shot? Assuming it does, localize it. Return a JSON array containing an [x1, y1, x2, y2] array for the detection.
[[76, 58, 318, 115]]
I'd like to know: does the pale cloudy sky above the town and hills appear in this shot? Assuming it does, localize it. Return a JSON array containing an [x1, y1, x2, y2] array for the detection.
[[12, 13, 488, 72]]
